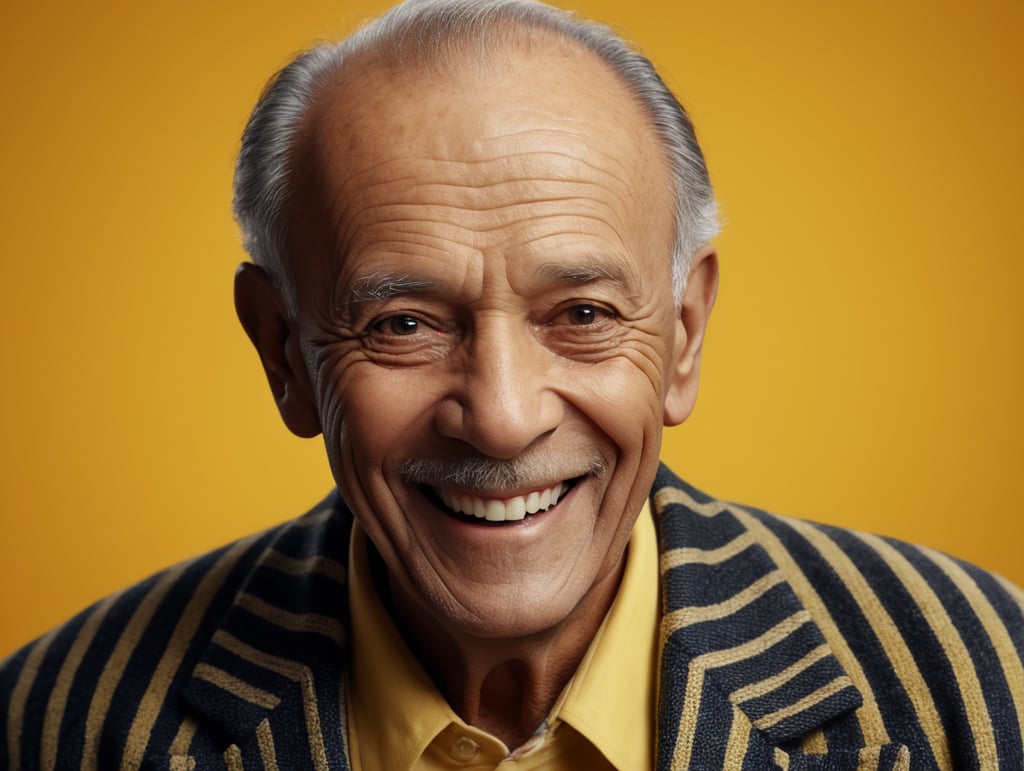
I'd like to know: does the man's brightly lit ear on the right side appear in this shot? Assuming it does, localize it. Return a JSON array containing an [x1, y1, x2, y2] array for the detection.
[[665, 244, 718, 426]]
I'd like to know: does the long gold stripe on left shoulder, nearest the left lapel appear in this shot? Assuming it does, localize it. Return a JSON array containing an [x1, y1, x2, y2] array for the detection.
[[121, 536, 257, 771]]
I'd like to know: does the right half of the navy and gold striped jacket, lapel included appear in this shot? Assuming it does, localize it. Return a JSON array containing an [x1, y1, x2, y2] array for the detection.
[[653, 469, 1024, 770]]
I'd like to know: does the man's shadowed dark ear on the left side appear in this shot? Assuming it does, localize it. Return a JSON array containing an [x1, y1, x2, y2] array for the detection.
[[234, 262, 321, 437]]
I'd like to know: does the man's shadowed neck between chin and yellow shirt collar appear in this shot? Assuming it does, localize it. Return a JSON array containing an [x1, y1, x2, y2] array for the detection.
[[372, 544, 625, 749]]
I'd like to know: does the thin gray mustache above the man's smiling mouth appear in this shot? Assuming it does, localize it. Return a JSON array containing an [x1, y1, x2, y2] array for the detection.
[[398, 453, 606, 490]]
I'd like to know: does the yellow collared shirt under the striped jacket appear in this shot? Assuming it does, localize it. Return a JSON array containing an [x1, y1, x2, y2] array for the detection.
[[347, 505, 659, 771]]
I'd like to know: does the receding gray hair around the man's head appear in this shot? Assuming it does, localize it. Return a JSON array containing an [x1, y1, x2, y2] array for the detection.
[[233, 0, 719, 312]]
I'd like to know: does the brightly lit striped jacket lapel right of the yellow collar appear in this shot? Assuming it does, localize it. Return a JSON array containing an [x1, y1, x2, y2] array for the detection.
[[652, 467, 862, 769]]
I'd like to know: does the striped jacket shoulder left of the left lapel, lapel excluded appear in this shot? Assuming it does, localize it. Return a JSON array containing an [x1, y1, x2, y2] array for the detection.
[[0, 489, 352, 769]]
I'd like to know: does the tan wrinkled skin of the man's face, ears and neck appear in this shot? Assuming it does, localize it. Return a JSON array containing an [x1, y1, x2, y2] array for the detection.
[[236, 41, 718, 747]]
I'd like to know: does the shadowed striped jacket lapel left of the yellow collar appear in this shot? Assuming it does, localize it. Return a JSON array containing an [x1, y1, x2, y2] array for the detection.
[[172, 492, 351, 769]]
